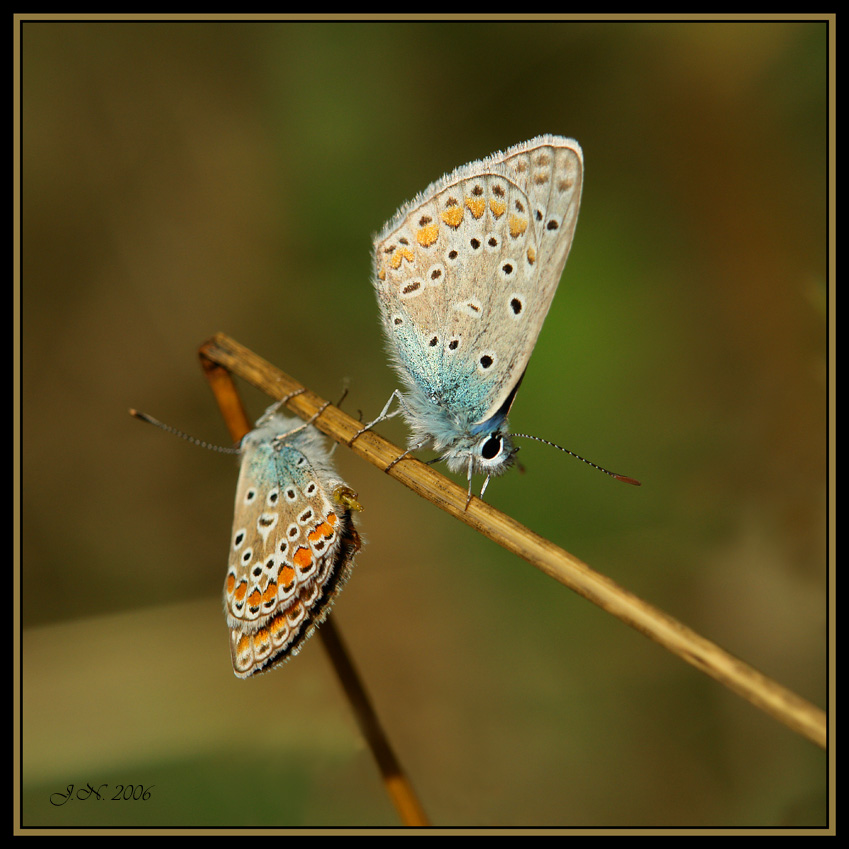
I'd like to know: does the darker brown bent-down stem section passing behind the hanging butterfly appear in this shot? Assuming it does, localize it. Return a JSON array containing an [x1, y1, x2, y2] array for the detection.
[[199, 337, 429, 826]]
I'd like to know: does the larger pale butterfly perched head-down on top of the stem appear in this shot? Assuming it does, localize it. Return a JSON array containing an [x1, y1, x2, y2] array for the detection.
[[364, 135, 584, 497]]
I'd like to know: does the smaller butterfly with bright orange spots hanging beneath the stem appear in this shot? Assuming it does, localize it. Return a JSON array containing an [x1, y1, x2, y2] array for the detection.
[[224, 416, 359, 678]]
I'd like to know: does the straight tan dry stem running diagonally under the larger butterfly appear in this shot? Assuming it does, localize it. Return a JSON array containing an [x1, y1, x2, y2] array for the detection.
[[201, 334, 827, 748]]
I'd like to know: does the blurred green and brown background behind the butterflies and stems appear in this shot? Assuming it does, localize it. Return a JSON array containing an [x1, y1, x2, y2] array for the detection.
[[21, 21, 828, 827]]
